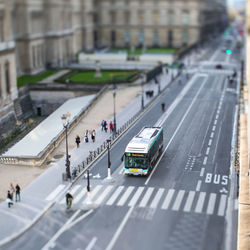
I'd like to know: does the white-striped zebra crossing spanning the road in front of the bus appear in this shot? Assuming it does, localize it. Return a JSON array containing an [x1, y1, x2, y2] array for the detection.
[[46, 185, 234, 216]]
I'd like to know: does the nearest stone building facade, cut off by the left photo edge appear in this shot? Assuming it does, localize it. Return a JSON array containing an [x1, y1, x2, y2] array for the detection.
[[0, 0, 18, 139]]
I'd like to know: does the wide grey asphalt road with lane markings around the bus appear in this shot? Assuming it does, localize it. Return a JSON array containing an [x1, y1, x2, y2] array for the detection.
[[4, 37, 240, 250]]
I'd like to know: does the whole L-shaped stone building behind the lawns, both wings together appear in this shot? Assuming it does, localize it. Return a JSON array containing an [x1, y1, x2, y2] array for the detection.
[[12, 0, 226, 74]]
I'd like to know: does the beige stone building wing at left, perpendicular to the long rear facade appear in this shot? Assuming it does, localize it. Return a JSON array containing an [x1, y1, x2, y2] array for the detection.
[[12, 0, 88, 74]]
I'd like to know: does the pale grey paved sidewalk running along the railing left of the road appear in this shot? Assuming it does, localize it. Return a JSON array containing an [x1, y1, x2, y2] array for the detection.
[[0, 70, 177, 247]]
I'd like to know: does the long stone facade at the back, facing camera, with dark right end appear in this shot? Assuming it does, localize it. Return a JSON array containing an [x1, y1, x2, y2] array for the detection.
[[93, 0, 226, 48]]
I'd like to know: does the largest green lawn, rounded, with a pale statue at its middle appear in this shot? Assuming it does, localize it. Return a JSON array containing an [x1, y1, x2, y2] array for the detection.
[[69, 71, 137, 83]]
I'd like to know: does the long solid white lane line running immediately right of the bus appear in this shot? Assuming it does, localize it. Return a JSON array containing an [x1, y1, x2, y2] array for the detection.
[[145, 78, 207, 185]]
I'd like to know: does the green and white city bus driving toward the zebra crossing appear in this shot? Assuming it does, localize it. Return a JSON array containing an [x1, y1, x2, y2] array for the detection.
[[124, 127, 163, 175]]
